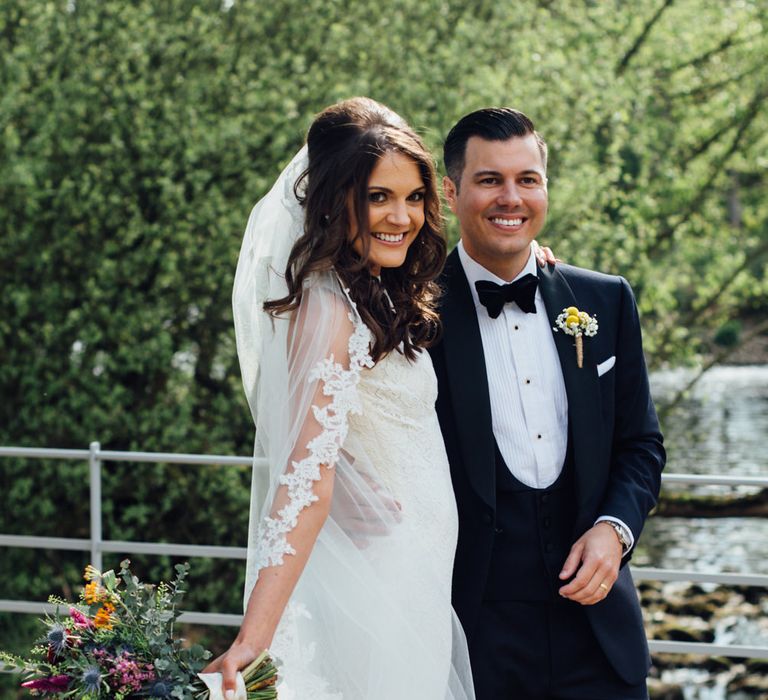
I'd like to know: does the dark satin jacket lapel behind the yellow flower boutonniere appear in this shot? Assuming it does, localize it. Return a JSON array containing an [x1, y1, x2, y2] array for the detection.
[[539, 266, 602, 524]]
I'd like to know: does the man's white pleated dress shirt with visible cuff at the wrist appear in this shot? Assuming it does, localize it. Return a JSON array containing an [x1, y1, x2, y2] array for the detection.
[[457, 241, 635, 551]]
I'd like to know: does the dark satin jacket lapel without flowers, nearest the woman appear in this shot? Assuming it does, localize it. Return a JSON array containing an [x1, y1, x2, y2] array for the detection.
[[441, 251, 496, 509]]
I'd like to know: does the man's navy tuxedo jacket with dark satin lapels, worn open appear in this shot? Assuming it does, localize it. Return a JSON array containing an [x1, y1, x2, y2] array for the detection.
[[430, 251, 665, 683]]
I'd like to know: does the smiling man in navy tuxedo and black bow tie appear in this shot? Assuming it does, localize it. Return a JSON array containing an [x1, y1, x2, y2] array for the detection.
[[432, 109, 665, 700]]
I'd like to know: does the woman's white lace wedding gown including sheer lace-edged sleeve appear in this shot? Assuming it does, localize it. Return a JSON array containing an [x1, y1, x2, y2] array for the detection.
[[240, 274, 474, 700]]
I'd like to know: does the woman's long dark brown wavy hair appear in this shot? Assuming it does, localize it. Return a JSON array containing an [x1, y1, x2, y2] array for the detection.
[[264, 97, 446, 361]]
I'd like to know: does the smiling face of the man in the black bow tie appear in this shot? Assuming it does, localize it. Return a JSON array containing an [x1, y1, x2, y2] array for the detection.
[[443, 134, 547, 280]]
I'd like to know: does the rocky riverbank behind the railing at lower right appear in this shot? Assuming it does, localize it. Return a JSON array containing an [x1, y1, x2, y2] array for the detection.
[[638, 581, 768, 700]]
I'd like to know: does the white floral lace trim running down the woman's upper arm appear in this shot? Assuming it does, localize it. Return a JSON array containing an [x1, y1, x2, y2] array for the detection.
[[256, 304, 373, 570]]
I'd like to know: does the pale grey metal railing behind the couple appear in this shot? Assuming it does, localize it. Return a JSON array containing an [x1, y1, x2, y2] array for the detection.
[[0, 442, 768, 659]]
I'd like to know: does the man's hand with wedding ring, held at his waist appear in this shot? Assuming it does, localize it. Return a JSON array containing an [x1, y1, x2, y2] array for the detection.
[[559, 522, 622, 605]]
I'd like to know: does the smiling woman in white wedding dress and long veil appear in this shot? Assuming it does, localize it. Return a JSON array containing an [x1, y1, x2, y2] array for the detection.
[[205, 98, 474, 700]]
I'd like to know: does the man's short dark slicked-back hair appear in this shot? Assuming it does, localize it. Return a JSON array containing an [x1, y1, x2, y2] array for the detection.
[[443, 107, 547, 189]]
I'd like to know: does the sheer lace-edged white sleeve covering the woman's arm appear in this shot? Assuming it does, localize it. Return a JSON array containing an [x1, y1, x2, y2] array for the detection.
[[249, 281, 373, 571]]
